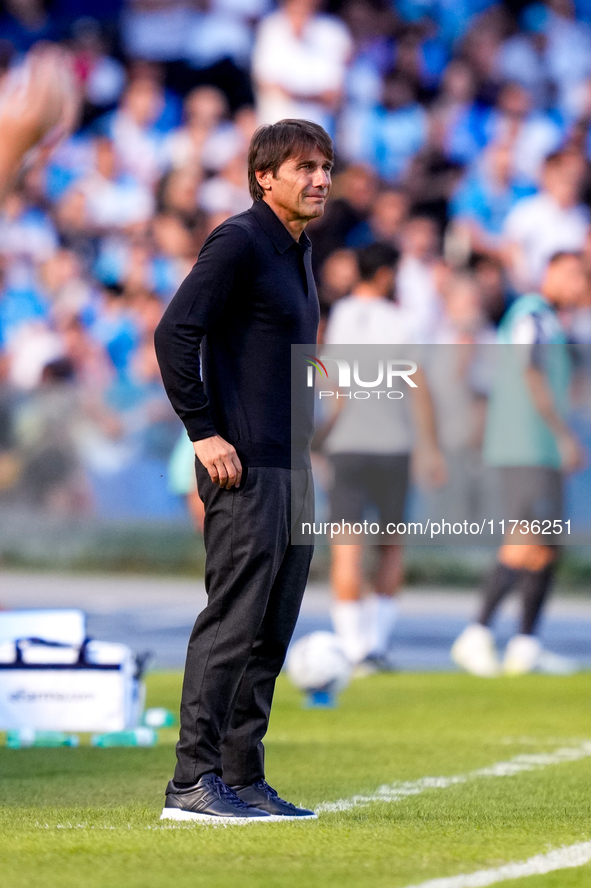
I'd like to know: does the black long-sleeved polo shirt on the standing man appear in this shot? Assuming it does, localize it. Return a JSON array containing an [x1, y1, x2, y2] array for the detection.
[[155, 201, 319, 468]]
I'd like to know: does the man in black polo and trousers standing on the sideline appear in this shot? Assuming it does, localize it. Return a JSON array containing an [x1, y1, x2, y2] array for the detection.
[[155, 120, 333, 823]]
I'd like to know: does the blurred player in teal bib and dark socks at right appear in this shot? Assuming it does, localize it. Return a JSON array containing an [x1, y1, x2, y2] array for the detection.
[[451, 252, 589, 677]]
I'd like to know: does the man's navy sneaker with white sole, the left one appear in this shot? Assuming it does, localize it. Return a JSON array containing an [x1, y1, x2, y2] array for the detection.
[[160, 771, 275, 824]]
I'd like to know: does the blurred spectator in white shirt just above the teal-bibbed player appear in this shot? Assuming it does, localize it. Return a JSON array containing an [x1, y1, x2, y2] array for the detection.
[[502, 151, 591, 292]]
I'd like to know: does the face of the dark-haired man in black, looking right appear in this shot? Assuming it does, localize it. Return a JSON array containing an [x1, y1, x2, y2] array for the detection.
[[260, 148, 332, 222]]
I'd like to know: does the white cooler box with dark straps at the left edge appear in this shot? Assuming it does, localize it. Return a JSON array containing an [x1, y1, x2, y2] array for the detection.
[[0, 609, 145, 732]]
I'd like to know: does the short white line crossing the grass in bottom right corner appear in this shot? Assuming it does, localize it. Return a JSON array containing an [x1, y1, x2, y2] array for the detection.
[[407, 842, 591, 888]]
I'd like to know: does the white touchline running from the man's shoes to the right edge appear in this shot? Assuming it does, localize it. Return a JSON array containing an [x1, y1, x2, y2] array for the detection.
[[315, 740, 591, 812]]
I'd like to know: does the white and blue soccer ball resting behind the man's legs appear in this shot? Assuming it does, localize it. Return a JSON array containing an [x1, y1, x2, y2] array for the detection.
[[287, 632, 352, 695]]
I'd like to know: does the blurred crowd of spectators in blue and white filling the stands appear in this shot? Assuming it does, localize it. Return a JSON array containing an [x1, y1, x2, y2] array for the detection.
[[0, 0, 591, 514]]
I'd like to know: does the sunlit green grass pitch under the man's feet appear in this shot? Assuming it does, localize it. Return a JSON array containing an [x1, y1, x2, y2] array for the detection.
[[0, 673, 591, 888]]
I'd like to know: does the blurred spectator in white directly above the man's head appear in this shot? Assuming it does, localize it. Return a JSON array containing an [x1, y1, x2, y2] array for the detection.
[[252, 0, 352, 133]]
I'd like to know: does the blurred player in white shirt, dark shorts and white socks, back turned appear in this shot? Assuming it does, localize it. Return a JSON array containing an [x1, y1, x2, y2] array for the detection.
[[324, 244, 446, 675]]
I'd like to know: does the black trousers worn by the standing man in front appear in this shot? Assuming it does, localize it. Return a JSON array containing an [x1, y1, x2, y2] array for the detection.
[[174, 460, 313, 785]]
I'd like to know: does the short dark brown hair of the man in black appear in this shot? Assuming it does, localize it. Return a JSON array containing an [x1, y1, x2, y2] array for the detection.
[[248, 119, 334, 200]]
